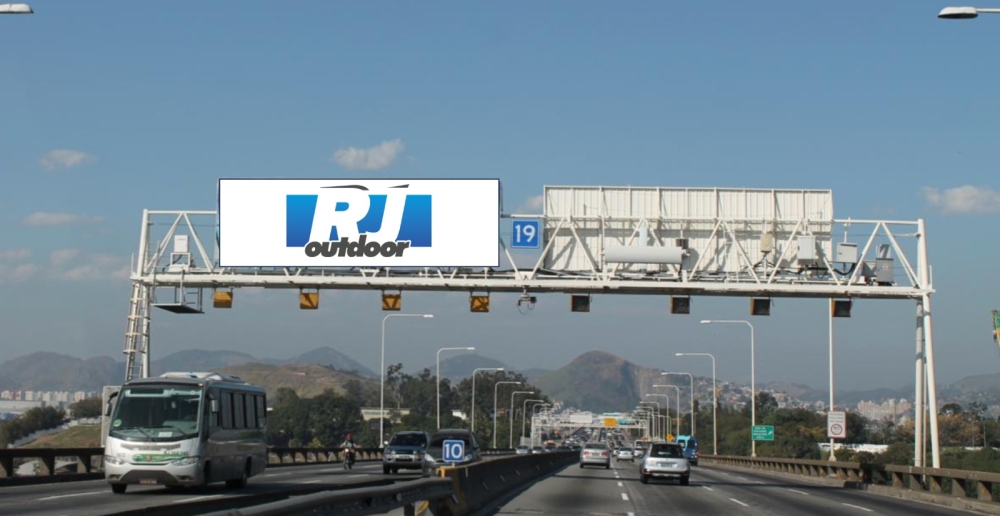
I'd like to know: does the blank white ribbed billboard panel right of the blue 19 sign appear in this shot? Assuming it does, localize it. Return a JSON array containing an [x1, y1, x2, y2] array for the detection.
[[543, 186, 833, 274]]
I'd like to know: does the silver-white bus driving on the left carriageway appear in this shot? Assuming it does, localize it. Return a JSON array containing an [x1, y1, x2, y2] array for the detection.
[[104, 373, 267, 494]]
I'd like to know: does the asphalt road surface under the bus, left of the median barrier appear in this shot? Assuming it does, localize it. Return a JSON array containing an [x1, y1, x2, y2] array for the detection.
[[0, 462, 420, 516]]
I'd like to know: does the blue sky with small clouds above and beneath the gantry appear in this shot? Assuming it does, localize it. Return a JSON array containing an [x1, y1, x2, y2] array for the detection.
[[0, 0, 1000, 389]]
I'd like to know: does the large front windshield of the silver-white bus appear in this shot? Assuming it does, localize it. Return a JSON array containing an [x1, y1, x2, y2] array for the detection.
[[110, 385, 202, 441]]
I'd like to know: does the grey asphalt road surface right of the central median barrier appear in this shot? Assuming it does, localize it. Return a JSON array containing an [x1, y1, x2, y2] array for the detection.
[[488, 461, 971, 516]]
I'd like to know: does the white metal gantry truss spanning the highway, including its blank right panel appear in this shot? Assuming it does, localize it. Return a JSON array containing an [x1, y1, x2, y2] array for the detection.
[[124, 186, 939, 466]]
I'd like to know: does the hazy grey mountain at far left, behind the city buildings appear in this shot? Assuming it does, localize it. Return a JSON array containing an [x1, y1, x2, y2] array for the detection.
[[0, 351, 125, 391]]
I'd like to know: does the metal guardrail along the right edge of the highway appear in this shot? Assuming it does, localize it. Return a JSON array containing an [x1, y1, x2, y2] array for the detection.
[[700, 455, 1000, 508]]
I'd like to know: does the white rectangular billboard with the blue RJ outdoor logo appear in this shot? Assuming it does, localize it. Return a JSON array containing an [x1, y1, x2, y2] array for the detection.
[[218, 179, 500, 267]]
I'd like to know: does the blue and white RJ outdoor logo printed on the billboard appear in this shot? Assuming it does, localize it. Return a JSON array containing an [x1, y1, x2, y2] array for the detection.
[[285, 184, 432, 258]]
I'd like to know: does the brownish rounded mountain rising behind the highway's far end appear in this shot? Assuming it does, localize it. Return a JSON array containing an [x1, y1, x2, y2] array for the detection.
[[532, 351, 664, 412]]
